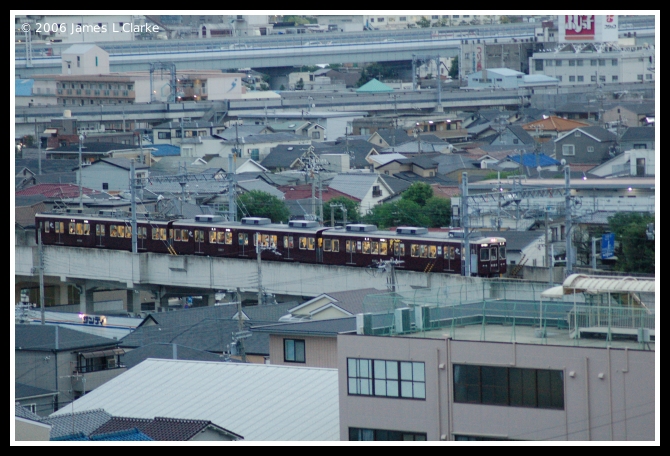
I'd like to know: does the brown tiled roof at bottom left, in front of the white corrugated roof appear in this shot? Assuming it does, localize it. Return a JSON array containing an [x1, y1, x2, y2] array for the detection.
[[91, 416, 239, 441]]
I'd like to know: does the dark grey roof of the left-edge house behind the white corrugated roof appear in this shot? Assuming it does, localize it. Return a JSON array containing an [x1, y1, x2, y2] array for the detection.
[[14, 324, 116, 351]]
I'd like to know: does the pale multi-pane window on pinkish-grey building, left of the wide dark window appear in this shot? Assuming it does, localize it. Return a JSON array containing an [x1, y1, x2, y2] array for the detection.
[[347, 358, 426, 399]]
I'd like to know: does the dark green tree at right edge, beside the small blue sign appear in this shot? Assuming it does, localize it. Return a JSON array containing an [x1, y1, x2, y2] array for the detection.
[[607, 212, 656, 273]]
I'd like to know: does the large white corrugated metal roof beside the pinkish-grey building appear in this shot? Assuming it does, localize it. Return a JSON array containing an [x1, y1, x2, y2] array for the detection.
[[52, 359, 340, 441]]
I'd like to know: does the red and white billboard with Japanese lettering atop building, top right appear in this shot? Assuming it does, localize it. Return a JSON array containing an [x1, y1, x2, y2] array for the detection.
[[558, 14, 619, 43]]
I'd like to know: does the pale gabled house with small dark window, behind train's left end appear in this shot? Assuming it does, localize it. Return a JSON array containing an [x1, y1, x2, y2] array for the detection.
[[81, 158, 149, 192]]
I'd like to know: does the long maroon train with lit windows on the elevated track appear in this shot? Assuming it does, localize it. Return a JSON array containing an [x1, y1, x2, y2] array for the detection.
[[35, 213, 507, 277]]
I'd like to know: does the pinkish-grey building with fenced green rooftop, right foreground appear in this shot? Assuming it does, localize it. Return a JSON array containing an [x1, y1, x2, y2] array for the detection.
[[337, 276, 658, 441]]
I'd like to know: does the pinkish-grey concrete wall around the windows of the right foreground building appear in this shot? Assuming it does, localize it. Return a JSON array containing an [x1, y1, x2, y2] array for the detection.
[[338, 335, 655, 441]]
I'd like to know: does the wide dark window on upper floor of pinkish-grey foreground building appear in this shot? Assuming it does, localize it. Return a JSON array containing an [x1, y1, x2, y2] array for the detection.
[[454, 364, 564, 410]]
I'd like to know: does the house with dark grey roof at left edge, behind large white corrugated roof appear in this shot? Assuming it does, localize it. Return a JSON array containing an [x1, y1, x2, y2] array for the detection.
[[14, 324, 126, 410]]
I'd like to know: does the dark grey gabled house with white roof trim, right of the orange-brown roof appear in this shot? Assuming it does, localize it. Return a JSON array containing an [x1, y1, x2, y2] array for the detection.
[[554, 127, 617, 165]]
